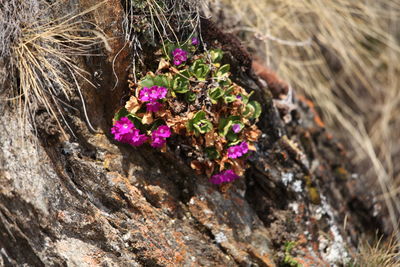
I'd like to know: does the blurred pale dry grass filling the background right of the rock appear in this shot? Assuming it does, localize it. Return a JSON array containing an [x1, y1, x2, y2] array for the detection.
[[209, 0, 400, 234]]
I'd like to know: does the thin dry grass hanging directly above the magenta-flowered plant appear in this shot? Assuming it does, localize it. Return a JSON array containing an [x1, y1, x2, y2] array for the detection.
[[121, 0, 205, 82]]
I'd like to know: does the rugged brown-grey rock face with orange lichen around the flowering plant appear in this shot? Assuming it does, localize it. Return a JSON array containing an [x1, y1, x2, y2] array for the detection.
[[0, 0, 379, 266]]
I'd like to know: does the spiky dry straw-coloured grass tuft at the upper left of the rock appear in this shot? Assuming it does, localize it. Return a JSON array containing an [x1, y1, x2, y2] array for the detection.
[[0, 0, 105, 137]]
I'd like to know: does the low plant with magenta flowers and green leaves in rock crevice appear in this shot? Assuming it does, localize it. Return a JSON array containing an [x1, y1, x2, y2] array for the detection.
[[111, 37, 261, 184]]
